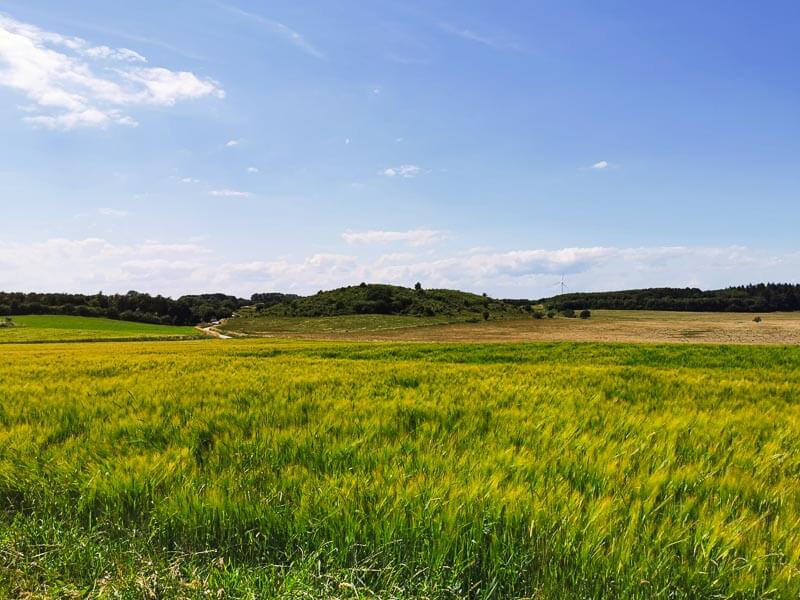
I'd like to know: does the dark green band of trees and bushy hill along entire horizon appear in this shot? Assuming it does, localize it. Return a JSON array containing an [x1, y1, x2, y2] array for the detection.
[[0, 283, 800, 325]]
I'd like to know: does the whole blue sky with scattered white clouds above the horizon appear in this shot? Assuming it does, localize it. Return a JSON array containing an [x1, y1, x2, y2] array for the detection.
[[0, 0, 800, 297]]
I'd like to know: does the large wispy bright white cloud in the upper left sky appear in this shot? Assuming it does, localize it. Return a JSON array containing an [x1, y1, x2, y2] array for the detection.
[[0, 14, 225, 130]]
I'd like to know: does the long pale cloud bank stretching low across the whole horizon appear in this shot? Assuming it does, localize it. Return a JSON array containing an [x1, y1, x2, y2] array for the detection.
[[0, 238, 800, 298]]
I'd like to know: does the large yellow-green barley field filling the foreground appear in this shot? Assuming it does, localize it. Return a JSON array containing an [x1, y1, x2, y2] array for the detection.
[[0, 340, 800, 599]]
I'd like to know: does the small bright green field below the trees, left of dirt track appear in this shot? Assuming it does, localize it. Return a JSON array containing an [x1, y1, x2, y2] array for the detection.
[[0, 315, 202, 344]]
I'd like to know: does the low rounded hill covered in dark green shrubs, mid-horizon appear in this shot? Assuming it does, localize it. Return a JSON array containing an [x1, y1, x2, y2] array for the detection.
[[250, 284, 525, 319]]
